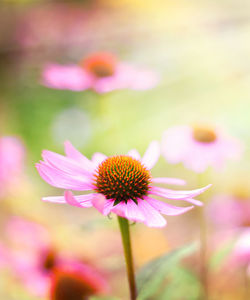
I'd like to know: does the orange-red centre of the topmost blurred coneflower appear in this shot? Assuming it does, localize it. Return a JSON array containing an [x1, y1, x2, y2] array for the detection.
[[81, 53, 117, 78]]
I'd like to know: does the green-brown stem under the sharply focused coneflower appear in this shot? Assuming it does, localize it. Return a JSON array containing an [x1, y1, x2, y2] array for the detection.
[[118, 216, 137, 300]]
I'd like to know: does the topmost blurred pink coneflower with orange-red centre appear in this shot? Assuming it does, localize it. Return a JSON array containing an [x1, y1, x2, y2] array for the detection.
[[42, 53, 158, 93]]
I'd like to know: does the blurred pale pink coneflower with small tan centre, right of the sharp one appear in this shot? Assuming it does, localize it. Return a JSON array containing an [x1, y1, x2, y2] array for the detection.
[[162, 126, 242, 173]]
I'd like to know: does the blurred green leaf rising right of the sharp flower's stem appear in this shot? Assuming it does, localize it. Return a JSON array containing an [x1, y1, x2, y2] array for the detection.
[[137, 244, 197, 300]]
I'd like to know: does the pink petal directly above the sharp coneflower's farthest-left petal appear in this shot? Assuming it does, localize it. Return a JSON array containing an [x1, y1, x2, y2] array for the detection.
[[42, 150, 91, 178]]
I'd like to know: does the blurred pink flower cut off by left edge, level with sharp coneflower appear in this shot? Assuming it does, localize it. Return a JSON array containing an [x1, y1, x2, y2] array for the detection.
[[0, 136, 25, 197]]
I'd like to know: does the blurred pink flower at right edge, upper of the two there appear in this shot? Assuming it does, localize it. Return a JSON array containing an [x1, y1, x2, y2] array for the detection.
[[207, 195, 250, 229]]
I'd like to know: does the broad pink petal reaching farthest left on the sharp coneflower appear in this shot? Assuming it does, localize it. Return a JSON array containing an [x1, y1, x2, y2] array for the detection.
[[36, 161, 93, 191]]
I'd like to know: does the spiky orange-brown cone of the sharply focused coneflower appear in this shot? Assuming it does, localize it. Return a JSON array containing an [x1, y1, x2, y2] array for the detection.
[[95, 155, 151, 205]]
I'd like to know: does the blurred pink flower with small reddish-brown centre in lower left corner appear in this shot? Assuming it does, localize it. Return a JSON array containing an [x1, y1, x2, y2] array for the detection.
[[1, 217, 107, 297]]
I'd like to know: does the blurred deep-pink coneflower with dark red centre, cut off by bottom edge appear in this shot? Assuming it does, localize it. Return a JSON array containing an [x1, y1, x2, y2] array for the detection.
[[50, 263, 107, 300]]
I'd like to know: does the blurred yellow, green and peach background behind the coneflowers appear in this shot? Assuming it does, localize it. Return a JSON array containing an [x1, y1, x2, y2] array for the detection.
[[0, 0, 250, 300]]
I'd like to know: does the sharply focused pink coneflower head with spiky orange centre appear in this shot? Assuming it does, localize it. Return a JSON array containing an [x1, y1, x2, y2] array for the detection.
[[36, 142, 209, 227]]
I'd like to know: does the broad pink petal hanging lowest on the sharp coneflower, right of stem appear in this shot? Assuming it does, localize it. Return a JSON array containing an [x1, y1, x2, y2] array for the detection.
[[138, 200, 167, 227]]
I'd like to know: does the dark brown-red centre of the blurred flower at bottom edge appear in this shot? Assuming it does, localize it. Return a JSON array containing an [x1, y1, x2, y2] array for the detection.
[[51, 272, 95, 300]]
